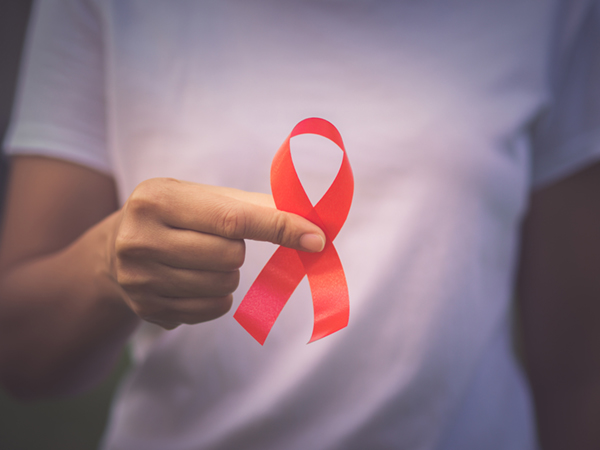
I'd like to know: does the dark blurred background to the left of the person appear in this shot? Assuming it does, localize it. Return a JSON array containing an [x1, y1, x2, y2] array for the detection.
[[0, 0, 129, 450]]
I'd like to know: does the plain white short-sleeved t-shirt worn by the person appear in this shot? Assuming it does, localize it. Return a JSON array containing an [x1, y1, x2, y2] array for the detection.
[[7, 0, 600, 450]]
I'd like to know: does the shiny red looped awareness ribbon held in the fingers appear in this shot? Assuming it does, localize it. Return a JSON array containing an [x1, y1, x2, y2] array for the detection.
[[233, 118, 354, 345]]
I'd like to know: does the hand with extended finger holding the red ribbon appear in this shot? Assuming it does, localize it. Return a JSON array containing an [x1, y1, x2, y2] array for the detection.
[[110, 178, 325, 329]]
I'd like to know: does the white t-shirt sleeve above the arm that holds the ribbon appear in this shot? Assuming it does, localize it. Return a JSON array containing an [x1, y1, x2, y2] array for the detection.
[[4, 0, 112, 174]]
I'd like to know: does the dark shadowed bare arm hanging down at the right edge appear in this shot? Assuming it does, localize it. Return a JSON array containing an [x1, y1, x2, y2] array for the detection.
[[519, 164, 600, 450]]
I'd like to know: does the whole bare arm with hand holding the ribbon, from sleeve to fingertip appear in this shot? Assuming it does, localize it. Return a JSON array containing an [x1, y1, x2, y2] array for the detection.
[[0, 157, 324, 397]]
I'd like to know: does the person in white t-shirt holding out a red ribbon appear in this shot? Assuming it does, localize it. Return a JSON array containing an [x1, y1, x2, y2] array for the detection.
[[0, 0, 600, 450]]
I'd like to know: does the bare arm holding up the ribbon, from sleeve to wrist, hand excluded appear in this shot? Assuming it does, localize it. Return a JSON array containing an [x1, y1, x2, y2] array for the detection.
[[0, 157, 136, 397]]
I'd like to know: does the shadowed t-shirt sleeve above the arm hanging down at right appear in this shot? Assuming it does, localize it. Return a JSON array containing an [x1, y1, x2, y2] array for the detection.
[[532, 1, 600, 188]]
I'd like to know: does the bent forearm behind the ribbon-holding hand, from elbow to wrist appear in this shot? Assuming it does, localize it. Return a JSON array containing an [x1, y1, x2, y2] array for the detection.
[[0, 213, 138, 397]]
